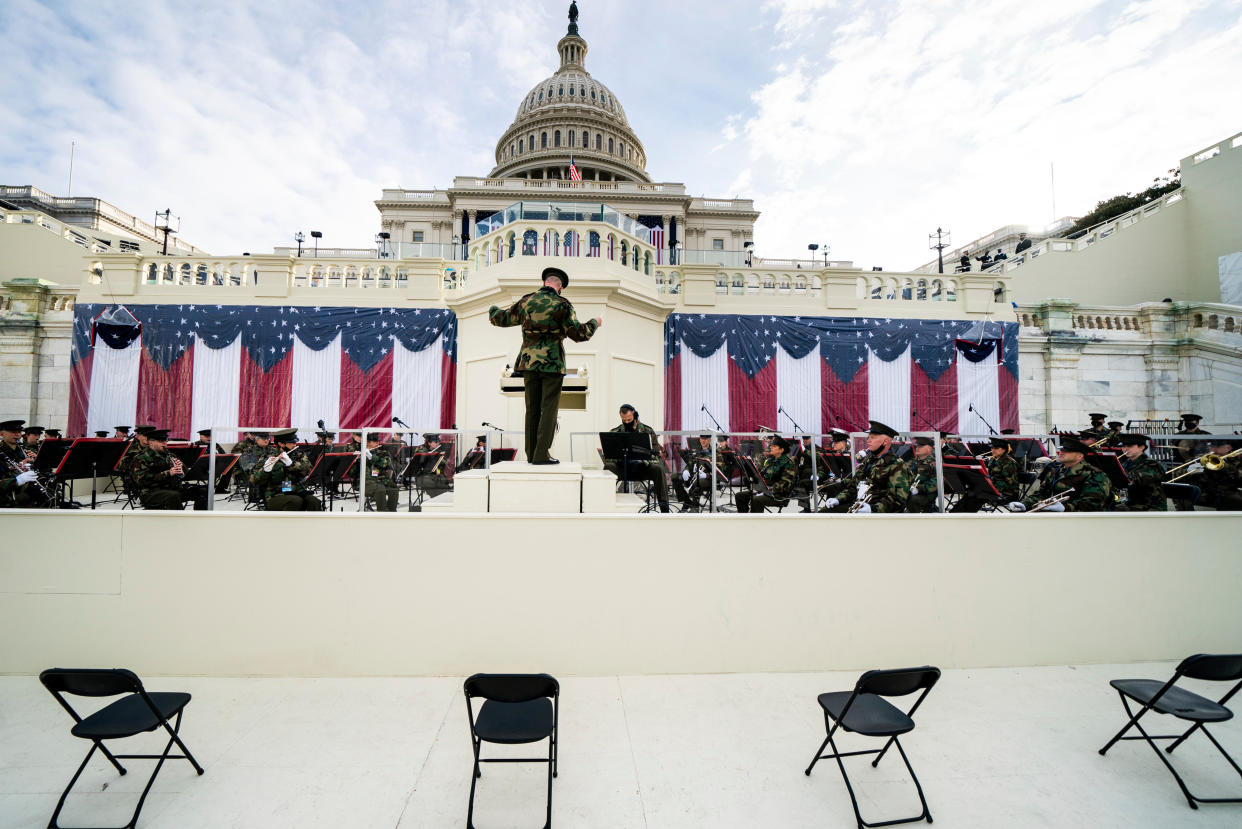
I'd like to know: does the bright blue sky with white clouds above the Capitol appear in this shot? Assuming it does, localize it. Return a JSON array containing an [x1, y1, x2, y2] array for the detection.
[[0, 0, 1242, 270]]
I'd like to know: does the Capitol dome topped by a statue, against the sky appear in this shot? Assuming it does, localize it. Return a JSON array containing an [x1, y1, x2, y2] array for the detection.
[[489, 2, 651, 183]]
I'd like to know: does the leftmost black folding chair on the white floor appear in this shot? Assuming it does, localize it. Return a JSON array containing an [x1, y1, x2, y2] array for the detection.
[[39, 667, 202, 829]]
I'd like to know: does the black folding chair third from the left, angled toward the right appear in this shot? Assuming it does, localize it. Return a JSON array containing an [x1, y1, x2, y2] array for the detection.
[[806, 666, 940, 828]]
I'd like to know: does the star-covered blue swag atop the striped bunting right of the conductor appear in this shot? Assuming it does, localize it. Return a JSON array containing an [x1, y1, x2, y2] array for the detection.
[[664, 313, 1018, 383]]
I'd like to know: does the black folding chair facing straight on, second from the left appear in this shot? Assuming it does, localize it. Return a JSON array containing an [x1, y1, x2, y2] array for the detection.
[[465, 674, 560, 829]]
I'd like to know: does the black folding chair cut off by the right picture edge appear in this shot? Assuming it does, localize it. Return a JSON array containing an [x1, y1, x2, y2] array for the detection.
[[1099, 654, 1242, 809]]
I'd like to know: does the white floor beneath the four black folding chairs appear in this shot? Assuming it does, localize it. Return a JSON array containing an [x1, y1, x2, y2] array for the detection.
[[0, 664, 1242, 829]]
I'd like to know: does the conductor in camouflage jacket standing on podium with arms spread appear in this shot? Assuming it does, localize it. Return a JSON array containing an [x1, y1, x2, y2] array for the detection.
[[488, 267, 604, 464]]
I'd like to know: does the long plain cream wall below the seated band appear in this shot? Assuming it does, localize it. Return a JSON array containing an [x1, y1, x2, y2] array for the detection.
[[0, 511, 1242, 676]]
